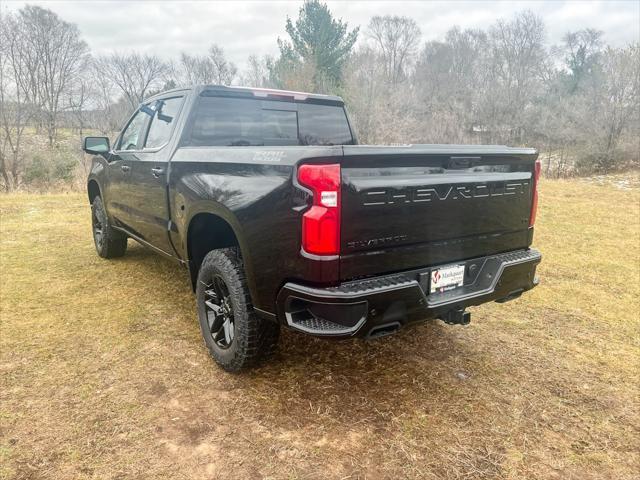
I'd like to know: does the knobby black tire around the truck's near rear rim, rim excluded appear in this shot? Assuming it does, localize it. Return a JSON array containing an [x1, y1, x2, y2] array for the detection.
[[196, 248, 280, 372]]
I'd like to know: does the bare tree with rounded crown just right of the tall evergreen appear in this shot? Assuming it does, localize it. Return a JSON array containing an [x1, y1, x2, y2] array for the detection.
[[367, 15, 420, 85]]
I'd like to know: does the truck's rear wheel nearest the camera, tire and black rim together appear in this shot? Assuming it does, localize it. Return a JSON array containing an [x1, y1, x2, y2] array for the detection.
[[196, 248, 280, 372]]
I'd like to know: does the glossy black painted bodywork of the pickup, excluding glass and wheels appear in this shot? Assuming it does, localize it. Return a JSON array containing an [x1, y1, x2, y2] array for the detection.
[[89, 87, 539, 336]]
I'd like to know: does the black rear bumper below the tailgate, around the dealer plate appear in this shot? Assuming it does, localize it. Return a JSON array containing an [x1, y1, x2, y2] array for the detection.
[[277, 249, 542, 338]]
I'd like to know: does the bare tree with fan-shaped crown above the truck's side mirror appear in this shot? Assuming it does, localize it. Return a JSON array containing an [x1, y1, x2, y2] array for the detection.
[[95, 52, 169, 109]]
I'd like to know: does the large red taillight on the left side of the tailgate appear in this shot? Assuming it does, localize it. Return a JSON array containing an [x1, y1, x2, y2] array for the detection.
[[298, 163, 340, 255]]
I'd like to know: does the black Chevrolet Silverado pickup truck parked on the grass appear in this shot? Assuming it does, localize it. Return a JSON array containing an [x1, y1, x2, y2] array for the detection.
[[84, 86, 540, 371]]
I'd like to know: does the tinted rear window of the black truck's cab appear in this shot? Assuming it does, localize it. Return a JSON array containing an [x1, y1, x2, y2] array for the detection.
[[182, 97, 353, 146]]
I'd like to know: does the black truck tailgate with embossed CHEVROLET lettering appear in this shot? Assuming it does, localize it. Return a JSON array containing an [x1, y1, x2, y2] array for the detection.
[[340, 145, 537, 280]]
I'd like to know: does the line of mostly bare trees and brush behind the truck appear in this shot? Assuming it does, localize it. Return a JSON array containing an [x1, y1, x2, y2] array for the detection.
[[0, 0, 640, 190]]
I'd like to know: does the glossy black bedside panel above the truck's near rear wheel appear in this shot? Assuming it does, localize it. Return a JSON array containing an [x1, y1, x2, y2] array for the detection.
[[169, 147, 342, 312]]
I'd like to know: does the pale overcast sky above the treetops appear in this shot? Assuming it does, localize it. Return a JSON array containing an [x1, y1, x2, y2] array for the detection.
[[0, 0, 640, 68]]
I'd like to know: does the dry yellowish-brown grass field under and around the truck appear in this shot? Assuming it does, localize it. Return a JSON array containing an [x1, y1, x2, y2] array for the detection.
[[0, 175, 640, 480]]
